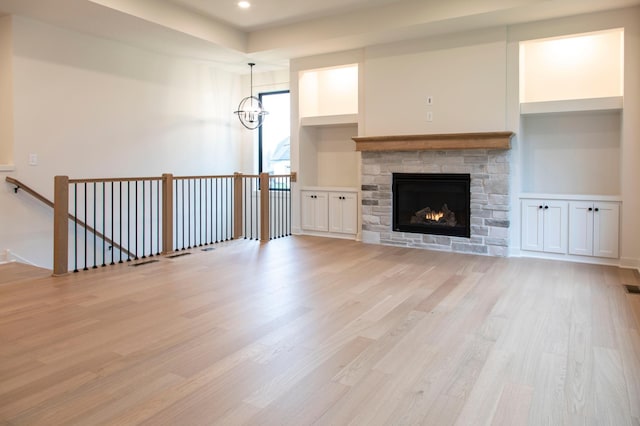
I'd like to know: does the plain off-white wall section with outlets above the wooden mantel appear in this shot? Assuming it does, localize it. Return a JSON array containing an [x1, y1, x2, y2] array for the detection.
[[364, 28, 506, 136]]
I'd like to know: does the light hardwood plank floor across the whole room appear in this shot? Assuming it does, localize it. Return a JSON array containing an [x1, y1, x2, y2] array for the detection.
[[0, 237, 640, 426]]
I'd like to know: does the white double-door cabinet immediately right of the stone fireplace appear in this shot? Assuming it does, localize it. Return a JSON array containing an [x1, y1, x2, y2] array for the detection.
[[522, 199, 568, 254]]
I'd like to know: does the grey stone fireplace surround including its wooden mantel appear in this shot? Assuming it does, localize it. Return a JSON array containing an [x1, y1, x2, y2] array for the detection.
[[353, 132, 513, 256]]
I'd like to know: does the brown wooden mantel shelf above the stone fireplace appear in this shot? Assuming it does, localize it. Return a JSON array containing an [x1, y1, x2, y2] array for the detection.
[[352, 132, 514, 151]]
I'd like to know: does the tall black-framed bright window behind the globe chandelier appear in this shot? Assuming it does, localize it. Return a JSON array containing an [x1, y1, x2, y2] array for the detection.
[[258, 90, 291, 175]]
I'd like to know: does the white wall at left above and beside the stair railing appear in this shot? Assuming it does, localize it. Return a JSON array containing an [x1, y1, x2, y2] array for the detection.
[[0, 17, 246, 267]]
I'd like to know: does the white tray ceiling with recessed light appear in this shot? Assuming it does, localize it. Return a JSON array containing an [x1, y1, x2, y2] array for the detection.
[[0, 0, 640, 72]]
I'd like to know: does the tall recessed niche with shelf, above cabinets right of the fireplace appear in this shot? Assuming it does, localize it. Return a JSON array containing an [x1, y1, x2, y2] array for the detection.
[[520, 28, 624, 195]]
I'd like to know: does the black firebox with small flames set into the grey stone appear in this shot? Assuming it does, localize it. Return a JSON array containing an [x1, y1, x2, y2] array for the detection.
[[392, 173, 471, 238]]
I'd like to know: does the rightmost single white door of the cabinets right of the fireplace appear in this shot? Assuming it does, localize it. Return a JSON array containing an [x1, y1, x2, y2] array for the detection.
[[593, 202, 620, 258]]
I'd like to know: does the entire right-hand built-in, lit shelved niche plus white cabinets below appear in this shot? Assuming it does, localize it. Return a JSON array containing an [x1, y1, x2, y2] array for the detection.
[[518, 28, 625, 263]]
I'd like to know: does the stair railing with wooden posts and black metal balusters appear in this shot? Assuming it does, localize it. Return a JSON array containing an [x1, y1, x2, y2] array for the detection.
[[53, 173, 296, 275]]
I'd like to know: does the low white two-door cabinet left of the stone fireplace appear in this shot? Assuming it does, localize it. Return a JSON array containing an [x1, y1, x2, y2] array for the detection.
[[300, 188, 358, 238]]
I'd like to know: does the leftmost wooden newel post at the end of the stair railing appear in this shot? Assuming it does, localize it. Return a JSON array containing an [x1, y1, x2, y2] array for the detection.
[[53, 176, 69, 276]]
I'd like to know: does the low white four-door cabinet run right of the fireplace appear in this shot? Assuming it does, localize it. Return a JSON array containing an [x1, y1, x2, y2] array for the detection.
[[520, 195, 620, 258]]
